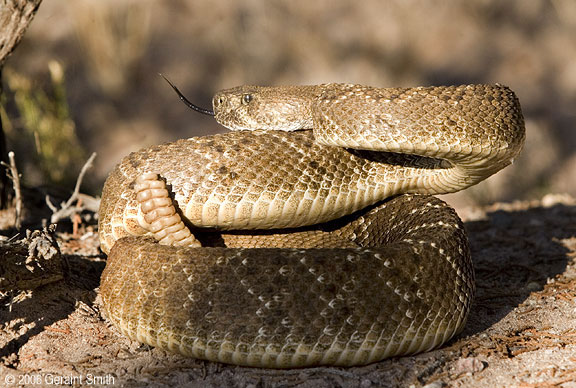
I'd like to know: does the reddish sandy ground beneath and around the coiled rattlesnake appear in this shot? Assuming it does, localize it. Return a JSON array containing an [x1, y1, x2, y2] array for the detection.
[[0, 195, 576, 388]]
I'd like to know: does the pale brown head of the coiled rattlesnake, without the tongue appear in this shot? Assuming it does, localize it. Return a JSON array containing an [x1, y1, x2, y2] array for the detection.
[[212, 86, 315, 131]]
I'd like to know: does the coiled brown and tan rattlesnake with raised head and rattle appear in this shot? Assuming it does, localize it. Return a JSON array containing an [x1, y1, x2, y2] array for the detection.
[[99, 84, 525, 368]]
